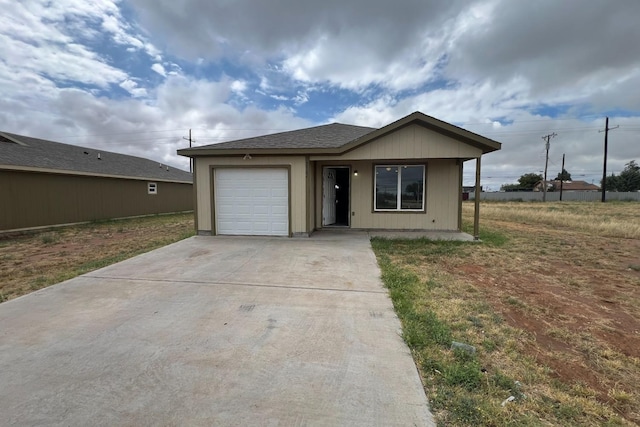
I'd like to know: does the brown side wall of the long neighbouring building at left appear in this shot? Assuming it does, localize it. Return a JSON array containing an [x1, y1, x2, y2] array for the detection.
[[0, 170, 193, 231]]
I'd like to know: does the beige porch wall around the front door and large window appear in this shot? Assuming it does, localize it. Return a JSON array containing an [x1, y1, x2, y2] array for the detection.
[[314, 159, 461, 231]]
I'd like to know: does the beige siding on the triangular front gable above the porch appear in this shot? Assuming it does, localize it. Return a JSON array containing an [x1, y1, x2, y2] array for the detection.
[[311, 125, 482, 161]]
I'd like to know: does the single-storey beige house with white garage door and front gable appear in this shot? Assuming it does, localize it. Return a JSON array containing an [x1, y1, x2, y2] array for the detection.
[[178, 112, 501, 237]]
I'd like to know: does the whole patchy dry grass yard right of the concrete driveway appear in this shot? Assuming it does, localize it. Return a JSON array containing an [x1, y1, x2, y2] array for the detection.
[[374, 202, 640, 426]]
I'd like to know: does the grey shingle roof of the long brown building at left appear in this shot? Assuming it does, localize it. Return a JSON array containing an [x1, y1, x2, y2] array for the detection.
[[0, 132, 193, 182]]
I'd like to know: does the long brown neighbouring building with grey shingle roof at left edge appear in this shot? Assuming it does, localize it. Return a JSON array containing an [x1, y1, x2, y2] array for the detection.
[[0, 132, 193, 232]]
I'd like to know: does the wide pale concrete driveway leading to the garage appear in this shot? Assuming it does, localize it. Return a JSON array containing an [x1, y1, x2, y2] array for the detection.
[[0, 233, 433, 426]]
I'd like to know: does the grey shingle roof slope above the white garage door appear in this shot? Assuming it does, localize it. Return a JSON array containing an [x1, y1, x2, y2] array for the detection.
[[185, 123, 375, 150]]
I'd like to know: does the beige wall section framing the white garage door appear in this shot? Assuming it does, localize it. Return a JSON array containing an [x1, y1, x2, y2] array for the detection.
[[195, 156, 309, 235]]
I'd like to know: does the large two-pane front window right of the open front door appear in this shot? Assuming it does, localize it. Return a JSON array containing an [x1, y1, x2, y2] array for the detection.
[[374, 165, 424, 211]]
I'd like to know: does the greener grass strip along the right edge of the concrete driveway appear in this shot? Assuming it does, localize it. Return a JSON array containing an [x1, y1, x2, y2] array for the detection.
[[372, 238, 531, 426]]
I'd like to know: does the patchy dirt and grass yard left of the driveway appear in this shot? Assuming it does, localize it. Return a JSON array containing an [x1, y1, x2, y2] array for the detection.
[[0, 213, 193, 302]]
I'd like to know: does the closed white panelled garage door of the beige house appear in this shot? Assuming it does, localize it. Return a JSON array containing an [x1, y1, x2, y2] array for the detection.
[[215, 168, 289, 236]]
